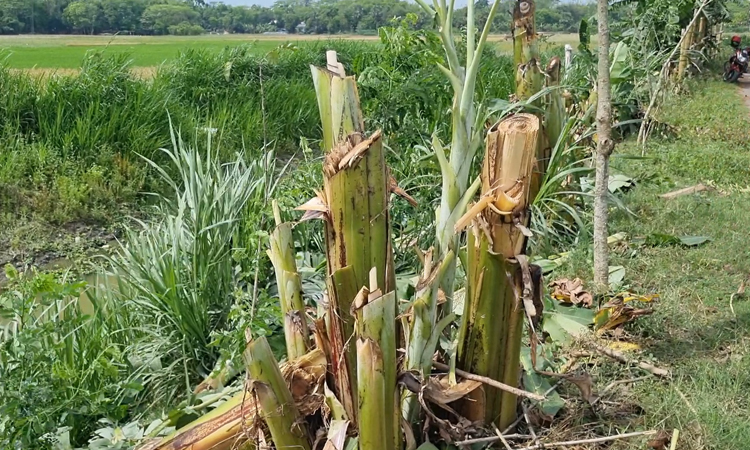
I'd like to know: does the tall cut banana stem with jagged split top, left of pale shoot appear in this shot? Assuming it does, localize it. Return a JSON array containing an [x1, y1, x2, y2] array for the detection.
[[304, 59, 396, 427]]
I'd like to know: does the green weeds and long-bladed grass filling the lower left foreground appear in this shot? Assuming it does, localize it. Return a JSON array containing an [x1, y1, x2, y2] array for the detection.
[[0, 122, 292, 448]]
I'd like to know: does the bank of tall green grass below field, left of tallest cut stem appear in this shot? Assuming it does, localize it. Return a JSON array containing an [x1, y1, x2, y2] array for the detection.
[[0, 42, 367, 223]]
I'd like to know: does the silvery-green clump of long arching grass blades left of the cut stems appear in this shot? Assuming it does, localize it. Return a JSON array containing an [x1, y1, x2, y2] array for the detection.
[[93, 126, 265, 398]]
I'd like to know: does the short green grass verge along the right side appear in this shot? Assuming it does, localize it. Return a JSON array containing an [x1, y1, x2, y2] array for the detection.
[[564, 81, 750, 450]]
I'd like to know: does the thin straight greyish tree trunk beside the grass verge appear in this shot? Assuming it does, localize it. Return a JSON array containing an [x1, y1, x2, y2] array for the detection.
[[594, 0, 615, 290]]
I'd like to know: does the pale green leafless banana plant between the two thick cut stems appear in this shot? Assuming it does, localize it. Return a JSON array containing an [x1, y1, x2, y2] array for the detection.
[[403, 0, 500, 420]]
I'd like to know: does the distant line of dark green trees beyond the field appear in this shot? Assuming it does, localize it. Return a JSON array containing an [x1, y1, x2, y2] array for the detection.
[[0, 0, 595, 35]]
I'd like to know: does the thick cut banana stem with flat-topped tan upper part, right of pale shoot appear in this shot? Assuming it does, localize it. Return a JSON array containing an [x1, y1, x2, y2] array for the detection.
[[458, 114, 541, 429]]
